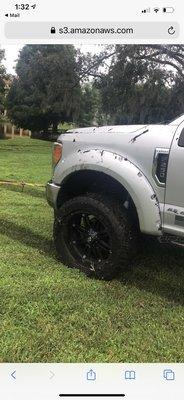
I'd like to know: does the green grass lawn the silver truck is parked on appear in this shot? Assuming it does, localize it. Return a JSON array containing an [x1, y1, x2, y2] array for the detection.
[[0, 138, 184, 362]]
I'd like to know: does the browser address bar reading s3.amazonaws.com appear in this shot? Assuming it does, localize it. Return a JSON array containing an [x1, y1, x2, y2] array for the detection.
[[5, 21, 180, 41]]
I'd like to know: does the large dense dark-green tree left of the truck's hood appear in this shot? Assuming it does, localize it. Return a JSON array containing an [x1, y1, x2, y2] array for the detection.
[[7, 45, 81, 131]]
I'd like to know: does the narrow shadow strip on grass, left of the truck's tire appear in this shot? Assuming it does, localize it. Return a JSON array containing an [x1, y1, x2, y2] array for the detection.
[[0, 218, 54, 257]]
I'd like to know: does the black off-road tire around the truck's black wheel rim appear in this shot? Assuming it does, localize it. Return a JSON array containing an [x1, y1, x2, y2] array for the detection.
[[54, 193, 138, 280]]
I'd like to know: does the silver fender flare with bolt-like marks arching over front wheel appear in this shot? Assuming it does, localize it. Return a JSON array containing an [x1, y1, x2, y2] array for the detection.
[[54, 149, 162, 236]]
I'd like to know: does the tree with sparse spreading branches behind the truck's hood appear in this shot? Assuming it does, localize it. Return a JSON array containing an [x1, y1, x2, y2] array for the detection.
[[95, 45, 184, 124]]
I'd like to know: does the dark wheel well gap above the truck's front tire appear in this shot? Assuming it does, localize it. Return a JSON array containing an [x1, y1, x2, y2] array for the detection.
[[57, 170, 139, 226]]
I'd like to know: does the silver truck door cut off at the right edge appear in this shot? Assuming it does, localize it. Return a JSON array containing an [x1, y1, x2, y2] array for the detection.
[[164, 122, 184, 236]]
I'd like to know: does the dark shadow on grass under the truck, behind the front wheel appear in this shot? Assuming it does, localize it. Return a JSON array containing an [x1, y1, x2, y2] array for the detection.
[[121, 239, 184, 305]]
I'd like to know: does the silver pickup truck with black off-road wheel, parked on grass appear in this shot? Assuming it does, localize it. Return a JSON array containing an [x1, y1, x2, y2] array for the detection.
[[47, 115, 184, 279]]
